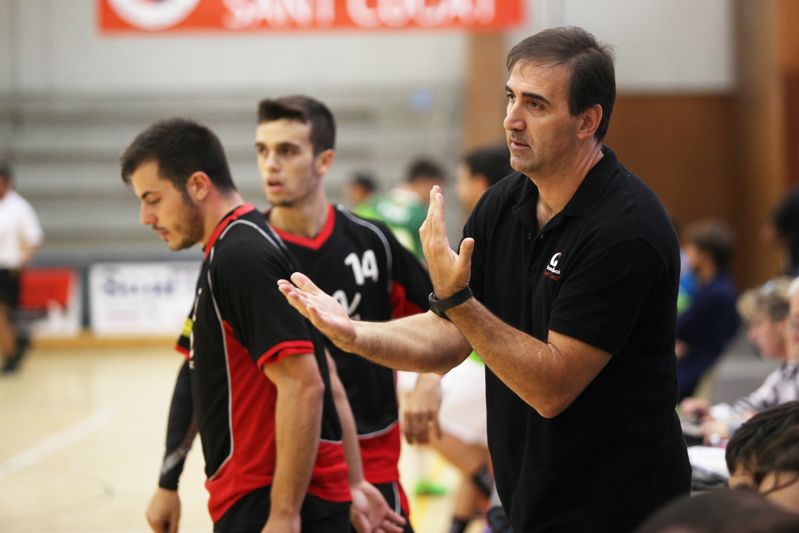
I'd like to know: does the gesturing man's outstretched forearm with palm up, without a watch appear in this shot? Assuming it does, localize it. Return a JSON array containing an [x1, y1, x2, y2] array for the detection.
[[345, 311, 471, 373]]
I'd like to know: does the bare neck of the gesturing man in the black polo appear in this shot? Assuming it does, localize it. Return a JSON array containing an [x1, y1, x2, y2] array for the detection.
[[530, 142, 602, 222]]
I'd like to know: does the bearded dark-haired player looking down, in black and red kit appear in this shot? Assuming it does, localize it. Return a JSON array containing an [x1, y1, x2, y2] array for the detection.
[[122, 119, 404, 533]]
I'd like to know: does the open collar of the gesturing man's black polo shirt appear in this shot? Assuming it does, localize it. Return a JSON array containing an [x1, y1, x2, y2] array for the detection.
[[511, 145, 618, 232]]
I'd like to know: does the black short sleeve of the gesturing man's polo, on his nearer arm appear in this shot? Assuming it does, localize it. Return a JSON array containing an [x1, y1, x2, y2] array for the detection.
[[549, 239, 676, 354]]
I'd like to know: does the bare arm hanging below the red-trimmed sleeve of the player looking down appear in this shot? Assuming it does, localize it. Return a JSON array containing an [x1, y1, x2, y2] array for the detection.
[[270, 381, 323, 517]]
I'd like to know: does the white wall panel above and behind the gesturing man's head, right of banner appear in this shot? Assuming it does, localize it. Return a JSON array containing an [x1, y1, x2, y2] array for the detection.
[[520, 0, 735, 92]]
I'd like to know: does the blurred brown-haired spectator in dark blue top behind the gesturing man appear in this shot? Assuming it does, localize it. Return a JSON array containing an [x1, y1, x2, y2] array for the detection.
[[677, 219, 740, 399]]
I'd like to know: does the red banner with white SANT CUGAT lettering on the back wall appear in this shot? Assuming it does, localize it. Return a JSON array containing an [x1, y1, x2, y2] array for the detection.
[[97, 0, 525, 33]]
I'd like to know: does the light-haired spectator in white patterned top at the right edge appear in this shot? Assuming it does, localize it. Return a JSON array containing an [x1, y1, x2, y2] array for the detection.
[[680, 278, 799, 441]]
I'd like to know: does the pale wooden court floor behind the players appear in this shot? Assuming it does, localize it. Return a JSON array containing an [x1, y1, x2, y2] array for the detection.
[[0, 343, 482, 533]]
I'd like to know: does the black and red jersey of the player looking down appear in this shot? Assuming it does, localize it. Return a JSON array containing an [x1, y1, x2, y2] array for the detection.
[[188, 205, 350, 522]]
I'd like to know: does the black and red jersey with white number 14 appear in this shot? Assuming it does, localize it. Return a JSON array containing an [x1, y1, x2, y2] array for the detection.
[[267, 205, 432, 483]]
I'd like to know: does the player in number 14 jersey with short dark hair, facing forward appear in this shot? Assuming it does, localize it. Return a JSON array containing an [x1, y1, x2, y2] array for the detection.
[[255, 96, 437, 530]]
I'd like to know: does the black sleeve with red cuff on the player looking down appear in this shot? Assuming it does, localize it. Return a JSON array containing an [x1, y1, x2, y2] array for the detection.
[[211, 239, 314, 367]]
